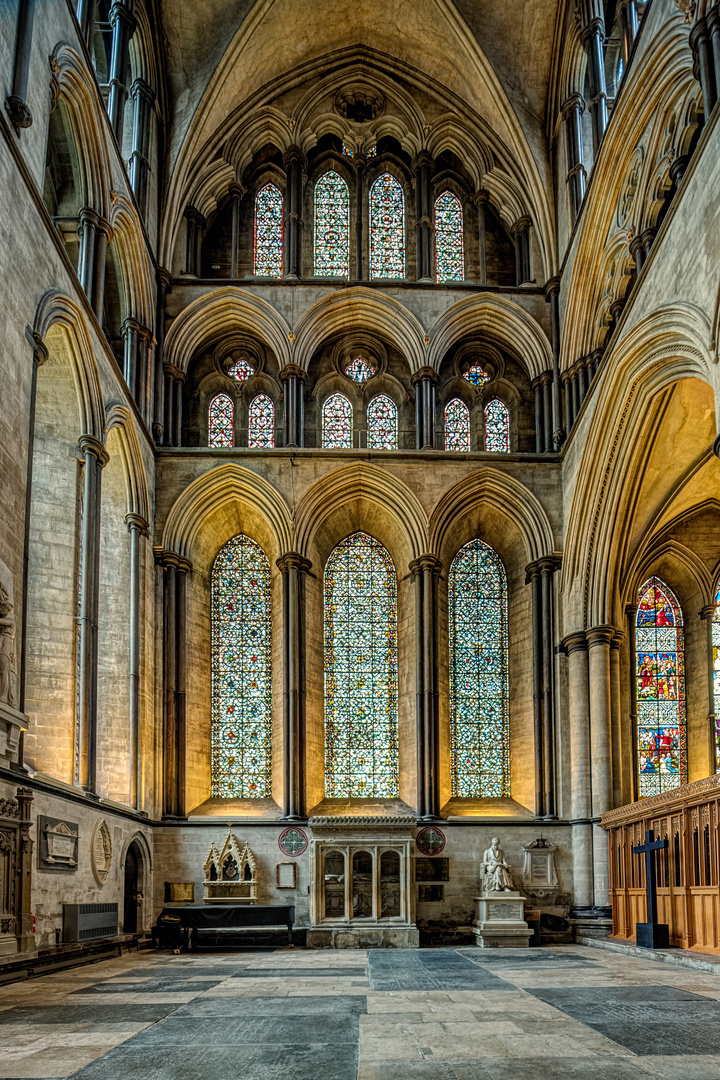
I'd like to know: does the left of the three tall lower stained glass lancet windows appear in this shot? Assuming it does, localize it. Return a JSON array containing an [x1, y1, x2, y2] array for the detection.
[[212, 534, 271, 798]]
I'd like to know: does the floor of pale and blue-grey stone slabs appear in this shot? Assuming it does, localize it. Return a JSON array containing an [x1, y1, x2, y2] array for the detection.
[[0, 946, 720, 1080]]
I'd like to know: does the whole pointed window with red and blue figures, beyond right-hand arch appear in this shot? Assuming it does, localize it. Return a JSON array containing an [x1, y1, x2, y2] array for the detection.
[[635, 578, 688, 796]]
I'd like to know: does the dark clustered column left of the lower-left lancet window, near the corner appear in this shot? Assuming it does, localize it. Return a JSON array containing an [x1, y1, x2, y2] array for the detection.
[[157, 551, 192, 818]]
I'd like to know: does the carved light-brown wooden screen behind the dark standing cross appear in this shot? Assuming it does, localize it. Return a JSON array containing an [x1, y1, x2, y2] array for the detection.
[[602, 775, 720, 955]]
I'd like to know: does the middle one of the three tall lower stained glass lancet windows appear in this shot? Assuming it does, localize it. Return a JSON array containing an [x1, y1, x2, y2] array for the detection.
[[325, 532, 397, 798]]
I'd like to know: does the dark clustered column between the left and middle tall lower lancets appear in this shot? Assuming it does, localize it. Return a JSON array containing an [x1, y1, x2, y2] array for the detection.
[[277, 551, 312, 821]]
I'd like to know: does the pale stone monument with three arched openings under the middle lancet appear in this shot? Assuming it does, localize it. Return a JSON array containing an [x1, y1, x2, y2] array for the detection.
[[308, 815, 420, 948]]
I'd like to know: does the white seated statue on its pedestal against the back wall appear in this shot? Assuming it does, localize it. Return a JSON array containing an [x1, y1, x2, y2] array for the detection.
[[473, 836, 532, 948]]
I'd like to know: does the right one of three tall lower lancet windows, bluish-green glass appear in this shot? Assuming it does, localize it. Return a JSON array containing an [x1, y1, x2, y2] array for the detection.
[[448, 540, 510, 798]]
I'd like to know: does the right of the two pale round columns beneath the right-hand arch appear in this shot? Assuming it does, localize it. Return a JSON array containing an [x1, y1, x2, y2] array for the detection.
[[586, 625, 615, 918]]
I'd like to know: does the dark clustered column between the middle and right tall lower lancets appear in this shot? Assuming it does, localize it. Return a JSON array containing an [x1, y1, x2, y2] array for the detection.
[[409, 555, 443, 821]]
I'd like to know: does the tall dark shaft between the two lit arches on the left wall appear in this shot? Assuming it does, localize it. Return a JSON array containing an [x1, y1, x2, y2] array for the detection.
[[77, 435, 109, 793]]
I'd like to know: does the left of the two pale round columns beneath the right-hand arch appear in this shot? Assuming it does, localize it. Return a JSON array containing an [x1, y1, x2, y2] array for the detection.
[[562, 632, 595, 918]]
